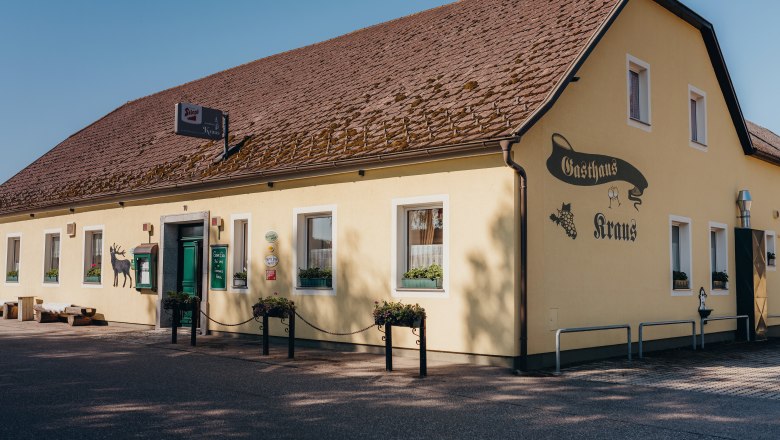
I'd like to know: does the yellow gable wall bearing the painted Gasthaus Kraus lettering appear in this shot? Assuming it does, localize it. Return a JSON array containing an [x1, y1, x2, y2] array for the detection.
[[515, 0, 780, 354]]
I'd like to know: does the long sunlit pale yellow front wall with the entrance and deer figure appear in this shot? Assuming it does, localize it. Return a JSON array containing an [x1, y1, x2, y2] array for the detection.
[[0, 156, 518, 356]]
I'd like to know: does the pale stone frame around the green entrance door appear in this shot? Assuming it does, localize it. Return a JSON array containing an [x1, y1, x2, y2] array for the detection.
[[155, 211, 211, 334]]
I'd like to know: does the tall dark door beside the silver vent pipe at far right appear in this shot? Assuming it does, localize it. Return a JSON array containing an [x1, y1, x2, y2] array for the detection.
[[734, 228, 769, 341]]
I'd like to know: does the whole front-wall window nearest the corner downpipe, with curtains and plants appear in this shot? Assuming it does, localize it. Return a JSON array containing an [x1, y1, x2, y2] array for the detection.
[[392, 196, 449, 296]]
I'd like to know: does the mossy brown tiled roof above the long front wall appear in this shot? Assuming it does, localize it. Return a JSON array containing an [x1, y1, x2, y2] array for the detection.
[[0, 0, 619, 214]]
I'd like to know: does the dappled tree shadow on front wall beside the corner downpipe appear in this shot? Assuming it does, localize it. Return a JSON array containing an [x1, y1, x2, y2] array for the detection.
[[464, 180, 516, 353]]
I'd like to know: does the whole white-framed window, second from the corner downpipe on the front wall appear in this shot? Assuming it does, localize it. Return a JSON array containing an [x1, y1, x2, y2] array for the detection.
[[293, 206, 336, 295]]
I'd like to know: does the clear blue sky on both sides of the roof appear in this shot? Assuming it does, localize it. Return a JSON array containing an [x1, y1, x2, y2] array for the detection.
[[0, 0, 780, 182]]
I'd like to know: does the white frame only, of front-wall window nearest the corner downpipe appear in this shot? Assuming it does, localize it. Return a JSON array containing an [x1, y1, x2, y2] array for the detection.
[[390, 194, 451, 299]]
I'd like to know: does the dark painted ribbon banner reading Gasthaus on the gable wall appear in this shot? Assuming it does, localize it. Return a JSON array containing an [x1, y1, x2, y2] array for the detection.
[[547, 133, 648, 211]]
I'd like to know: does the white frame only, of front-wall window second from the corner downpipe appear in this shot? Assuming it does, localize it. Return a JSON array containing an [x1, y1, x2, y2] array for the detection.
[[290, 205, 339, 296]]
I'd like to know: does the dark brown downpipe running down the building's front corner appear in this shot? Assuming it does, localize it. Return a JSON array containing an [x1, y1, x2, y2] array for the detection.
[[499, 136, 528, 372]]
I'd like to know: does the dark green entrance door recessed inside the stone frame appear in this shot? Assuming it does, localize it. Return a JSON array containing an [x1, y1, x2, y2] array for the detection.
[[176, 223, 203, 326]]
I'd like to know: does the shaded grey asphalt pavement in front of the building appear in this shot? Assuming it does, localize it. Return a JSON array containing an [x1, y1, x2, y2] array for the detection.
[[0, 320, 780, 439]]
